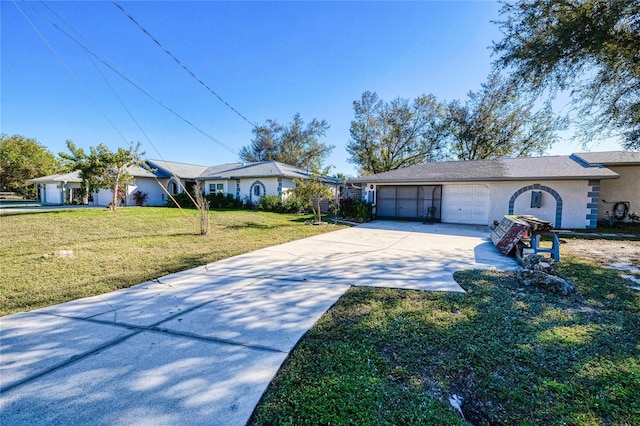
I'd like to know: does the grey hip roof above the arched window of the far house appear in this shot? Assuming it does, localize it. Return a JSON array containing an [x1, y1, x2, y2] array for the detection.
[[198, 161, 341, 183]]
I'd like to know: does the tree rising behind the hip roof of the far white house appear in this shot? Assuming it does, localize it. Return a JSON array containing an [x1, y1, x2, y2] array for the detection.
[[240, 114, 334, 170]]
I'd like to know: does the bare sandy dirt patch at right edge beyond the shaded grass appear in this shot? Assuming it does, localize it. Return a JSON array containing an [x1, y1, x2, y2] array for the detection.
[[562, 239, 640, 290]]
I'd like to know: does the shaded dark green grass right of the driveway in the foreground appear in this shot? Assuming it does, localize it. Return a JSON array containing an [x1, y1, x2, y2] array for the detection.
[[252, 253, 640, 425]]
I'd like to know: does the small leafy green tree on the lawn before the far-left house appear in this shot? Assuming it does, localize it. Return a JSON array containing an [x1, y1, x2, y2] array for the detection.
[[59, 140, 144, 211]]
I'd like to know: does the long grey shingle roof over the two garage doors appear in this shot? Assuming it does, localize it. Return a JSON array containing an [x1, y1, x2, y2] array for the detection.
[[350, 156, 619, 183]]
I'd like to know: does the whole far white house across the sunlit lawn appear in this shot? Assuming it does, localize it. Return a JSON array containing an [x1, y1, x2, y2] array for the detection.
[[27, 160, 342, 206]]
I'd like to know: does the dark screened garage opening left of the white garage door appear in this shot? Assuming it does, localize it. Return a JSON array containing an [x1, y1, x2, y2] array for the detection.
[[376, 185, 442, 222]]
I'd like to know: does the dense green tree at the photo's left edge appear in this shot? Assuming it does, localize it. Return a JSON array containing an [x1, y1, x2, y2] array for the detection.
[[0, 134, 60, 198]]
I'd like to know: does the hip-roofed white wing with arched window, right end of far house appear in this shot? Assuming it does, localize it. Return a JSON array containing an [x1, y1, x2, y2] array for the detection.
[[198, 161, 342, 208]]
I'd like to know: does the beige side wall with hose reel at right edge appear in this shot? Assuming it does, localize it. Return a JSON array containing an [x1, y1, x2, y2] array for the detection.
[[598, 166, 640, 220]]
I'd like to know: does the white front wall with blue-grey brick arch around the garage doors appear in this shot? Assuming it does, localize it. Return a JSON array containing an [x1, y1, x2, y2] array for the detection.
[[362, 180, 600, 229]]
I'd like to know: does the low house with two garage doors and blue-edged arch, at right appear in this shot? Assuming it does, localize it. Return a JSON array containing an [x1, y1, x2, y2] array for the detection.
[[350, 151, 640, 229]]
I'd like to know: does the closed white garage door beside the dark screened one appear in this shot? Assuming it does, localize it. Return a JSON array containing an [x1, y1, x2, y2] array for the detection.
[[442, 185, 490, 225]]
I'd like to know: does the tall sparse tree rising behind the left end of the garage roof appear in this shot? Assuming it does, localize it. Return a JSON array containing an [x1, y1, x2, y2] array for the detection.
[[347, 91, 444, 175]]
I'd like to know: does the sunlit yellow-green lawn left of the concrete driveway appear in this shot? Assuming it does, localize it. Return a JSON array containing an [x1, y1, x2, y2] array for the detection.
[[0, 207, 339, 315]]
